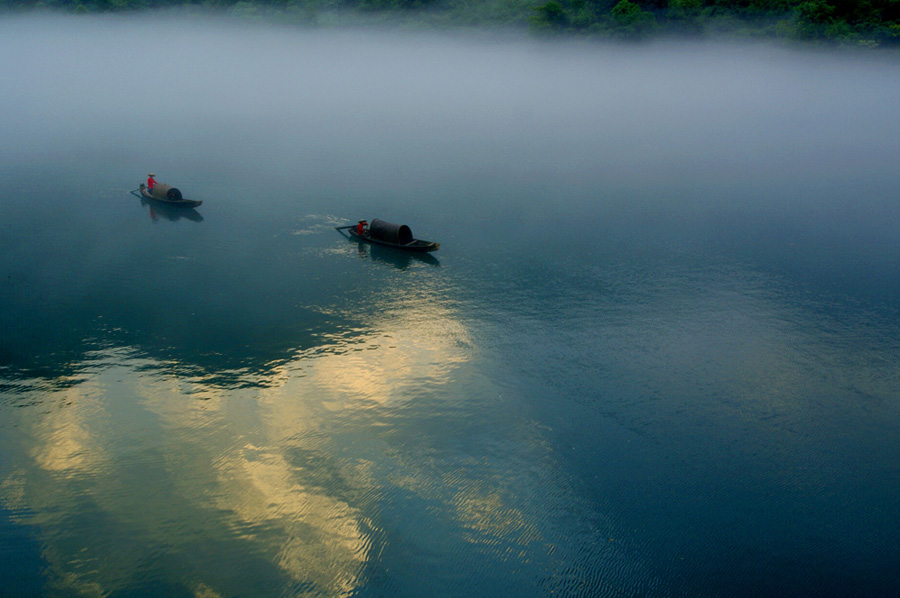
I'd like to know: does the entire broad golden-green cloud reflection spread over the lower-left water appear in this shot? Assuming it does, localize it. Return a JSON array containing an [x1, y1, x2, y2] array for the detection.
[[0, 288, 469, 597]]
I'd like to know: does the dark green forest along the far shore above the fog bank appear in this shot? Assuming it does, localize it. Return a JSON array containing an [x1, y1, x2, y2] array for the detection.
[[0, 0, 900, 47]]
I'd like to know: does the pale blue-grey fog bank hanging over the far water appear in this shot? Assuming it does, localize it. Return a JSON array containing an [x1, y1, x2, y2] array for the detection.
[[0, 16, 900, 203]]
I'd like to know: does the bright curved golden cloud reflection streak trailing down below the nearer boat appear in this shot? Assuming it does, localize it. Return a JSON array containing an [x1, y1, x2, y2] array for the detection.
[[202, 296, 468, 595]]
